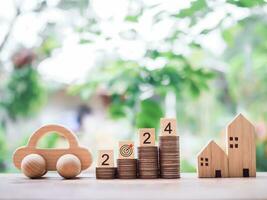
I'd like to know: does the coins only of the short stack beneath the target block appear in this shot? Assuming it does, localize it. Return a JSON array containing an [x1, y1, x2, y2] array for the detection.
[[117, 159, 137, 179]]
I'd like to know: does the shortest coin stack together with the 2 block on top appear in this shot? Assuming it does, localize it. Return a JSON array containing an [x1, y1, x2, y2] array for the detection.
[[96, 150, 117, 179]]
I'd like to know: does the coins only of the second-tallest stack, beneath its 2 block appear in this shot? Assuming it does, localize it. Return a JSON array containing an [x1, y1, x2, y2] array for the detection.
[[138, 146, 158, 179]]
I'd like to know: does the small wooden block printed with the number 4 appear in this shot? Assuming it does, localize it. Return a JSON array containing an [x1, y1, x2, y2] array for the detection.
[[160, 118, 177, 136]]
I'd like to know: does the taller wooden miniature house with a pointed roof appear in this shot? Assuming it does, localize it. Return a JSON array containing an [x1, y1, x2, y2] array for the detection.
[[226, 114, 256, 177]]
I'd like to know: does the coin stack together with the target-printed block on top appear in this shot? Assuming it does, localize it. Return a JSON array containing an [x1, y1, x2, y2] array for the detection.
[[117, 141, 137, 179]]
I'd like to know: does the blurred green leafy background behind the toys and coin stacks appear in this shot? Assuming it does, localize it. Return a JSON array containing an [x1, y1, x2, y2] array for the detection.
[[0, 0, 267, 172]]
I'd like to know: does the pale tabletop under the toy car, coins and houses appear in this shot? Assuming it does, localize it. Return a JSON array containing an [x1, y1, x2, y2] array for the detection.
[[0, 173, 267, 200]]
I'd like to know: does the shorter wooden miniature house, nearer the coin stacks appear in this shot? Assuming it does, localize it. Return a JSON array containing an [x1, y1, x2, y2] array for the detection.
[[197, 141, 228, 178]]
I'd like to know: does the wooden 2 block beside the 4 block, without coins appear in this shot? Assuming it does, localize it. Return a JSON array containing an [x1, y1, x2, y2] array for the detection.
[[139, 128, 155, 147]]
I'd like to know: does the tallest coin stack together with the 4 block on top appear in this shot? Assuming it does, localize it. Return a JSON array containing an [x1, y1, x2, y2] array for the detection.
[[159, 118, 180, 179]]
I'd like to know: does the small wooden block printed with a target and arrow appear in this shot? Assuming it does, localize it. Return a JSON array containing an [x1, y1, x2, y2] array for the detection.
[[119, 141, 134, 159]]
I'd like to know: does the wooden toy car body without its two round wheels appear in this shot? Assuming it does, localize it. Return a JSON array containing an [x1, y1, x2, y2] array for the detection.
[[13, 125, 92, 171]]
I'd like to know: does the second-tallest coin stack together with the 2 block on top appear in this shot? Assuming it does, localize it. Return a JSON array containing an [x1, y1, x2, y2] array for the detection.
[[138, 128, 159, 179]]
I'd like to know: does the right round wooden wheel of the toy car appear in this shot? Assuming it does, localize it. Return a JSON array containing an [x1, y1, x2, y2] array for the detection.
[[56, 154, 82, 179]]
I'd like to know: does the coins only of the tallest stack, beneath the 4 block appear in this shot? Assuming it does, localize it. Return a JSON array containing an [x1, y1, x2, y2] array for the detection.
[[159, 136, 180, 179]]
